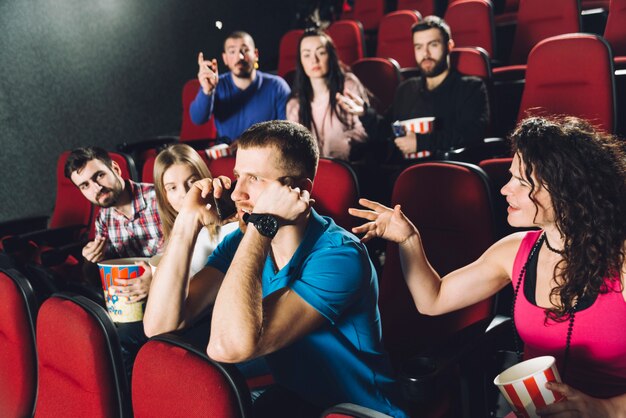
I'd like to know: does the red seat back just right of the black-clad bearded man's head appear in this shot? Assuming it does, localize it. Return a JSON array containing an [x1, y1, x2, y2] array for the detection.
[[444, 0, 495, 57]]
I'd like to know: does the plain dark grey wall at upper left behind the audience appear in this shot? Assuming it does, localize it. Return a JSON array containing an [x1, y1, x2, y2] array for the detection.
[[0, 0, 295, 221]]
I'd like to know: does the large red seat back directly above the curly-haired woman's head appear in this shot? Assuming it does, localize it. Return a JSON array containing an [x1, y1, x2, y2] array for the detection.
[[518, 34, 616, 132]]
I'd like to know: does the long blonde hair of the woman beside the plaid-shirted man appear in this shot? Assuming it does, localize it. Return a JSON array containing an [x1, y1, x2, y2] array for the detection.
[[154, 144, 219, 242]]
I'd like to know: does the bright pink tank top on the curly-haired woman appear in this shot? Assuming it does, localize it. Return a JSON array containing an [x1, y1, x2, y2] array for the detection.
[[511, 231, 626, 398]]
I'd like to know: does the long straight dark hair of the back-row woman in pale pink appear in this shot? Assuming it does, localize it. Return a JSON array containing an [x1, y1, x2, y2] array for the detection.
[[291, 29, 347, 136]]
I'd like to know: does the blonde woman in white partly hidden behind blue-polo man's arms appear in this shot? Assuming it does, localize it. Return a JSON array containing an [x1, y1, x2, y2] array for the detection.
[[154, 144, 237, 276]]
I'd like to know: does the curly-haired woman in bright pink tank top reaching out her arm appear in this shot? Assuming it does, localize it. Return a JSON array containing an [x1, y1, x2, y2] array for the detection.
[[350, 117, 626, 418]]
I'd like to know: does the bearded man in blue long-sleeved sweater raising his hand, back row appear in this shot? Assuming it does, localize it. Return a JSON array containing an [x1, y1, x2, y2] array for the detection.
[[189, 31, 291, 144]]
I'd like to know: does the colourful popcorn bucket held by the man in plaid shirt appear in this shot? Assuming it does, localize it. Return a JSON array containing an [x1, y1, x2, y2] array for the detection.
[[98, 257, 148, 322]]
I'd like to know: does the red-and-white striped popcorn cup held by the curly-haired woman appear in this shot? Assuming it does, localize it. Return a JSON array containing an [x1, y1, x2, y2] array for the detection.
[[493, 356, 563, 418]]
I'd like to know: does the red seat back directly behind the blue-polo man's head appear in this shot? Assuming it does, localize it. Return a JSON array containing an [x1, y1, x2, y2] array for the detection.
[[311, 158, 359, 231]]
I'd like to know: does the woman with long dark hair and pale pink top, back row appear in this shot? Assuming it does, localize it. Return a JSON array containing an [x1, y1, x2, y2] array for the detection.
[[287, 30, 368, 161]]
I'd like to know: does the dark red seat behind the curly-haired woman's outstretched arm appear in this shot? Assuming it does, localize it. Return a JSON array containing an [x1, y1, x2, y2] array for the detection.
[[379, 162, 495, 365]]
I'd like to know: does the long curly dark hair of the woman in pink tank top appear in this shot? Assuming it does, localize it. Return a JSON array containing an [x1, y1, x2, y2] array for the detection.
[[510, 116, 626, 321]]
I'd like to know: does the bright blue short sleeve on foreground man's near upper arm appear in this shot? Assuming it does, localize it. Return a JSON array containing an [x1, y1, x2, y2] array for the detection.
[[289, 240, 372, 324]]
